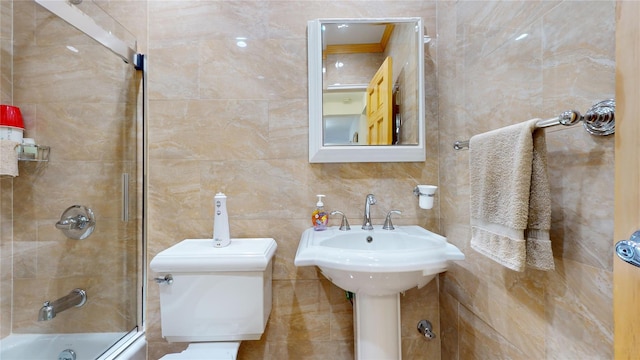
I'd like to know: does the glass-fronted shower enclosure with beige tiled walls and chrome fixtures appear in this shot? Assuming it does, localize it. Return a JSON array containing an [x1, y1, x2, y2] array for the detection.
[[0, 0, 145, 360]]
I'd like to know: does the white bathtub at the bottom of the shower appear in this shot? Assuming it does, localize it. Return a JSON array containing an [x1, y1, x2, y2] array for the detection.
[[0, 332, 146, 360]]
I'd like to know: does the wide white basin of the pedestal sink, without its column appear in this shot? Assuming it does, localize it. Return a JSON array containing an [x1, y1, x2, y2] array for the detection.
[[294, 226, 464, 296]]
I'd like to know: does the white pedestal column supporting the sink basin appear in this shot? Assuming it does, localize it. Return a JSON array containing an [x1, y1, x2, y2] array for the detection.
[[353, 294, 402, 360]]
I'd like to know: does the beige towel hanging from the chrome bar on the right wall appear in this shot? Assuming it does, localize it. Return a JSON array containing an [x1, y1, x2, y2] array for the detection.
[[469, 119, 554, 271]]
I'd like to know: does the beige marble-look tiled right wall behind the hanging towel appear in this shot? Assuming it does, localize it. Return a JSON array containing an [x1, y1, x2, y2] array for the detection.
[[437, 1, 615, 359]]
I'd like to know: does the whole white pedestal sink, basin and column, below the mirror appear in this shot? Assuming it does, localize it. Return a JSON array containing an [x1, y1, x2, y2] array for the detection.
[[295, 226, 464, 360]]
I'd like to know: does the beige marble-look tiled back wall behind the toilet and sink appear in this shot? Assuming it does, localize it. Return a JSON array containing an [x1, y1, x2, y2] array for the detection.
[[147, 1, 439, 360]]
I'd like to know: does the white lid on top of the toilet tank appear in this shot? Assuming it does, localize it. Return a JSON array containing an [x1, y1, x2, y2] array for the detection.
[[149, 238, 278, 272]]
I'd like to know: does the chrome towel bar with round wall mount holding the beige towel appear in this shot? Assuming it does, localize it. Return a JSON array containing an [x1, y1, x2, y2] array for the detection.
[[453, 99, 616, 150]]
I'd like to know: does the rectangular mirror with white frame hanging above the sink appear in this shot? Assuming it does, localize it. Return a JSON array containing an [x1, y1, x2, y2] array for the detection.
[[308, 18, 426, 163]]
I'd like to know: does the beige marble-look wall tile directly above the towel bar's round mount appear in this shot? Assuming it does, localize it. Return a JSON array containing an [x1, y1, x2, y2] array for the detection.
[[542, 1, 615, 113]]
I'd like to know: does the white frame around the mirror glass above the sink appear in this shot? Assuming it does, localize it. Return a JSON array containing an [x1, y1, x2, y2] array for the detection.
[[307, 17, 426, 163]]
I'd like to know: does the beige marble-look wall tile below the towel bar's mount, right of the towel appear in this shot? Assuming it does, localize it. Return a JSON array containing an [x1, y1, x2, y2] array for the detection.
[[547, 128, 614, 271]]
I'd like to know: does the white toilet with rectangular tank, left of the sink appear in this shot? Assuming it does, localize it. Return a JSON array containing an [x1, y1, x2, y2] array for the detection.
[[150, 238, 277, 360]]
